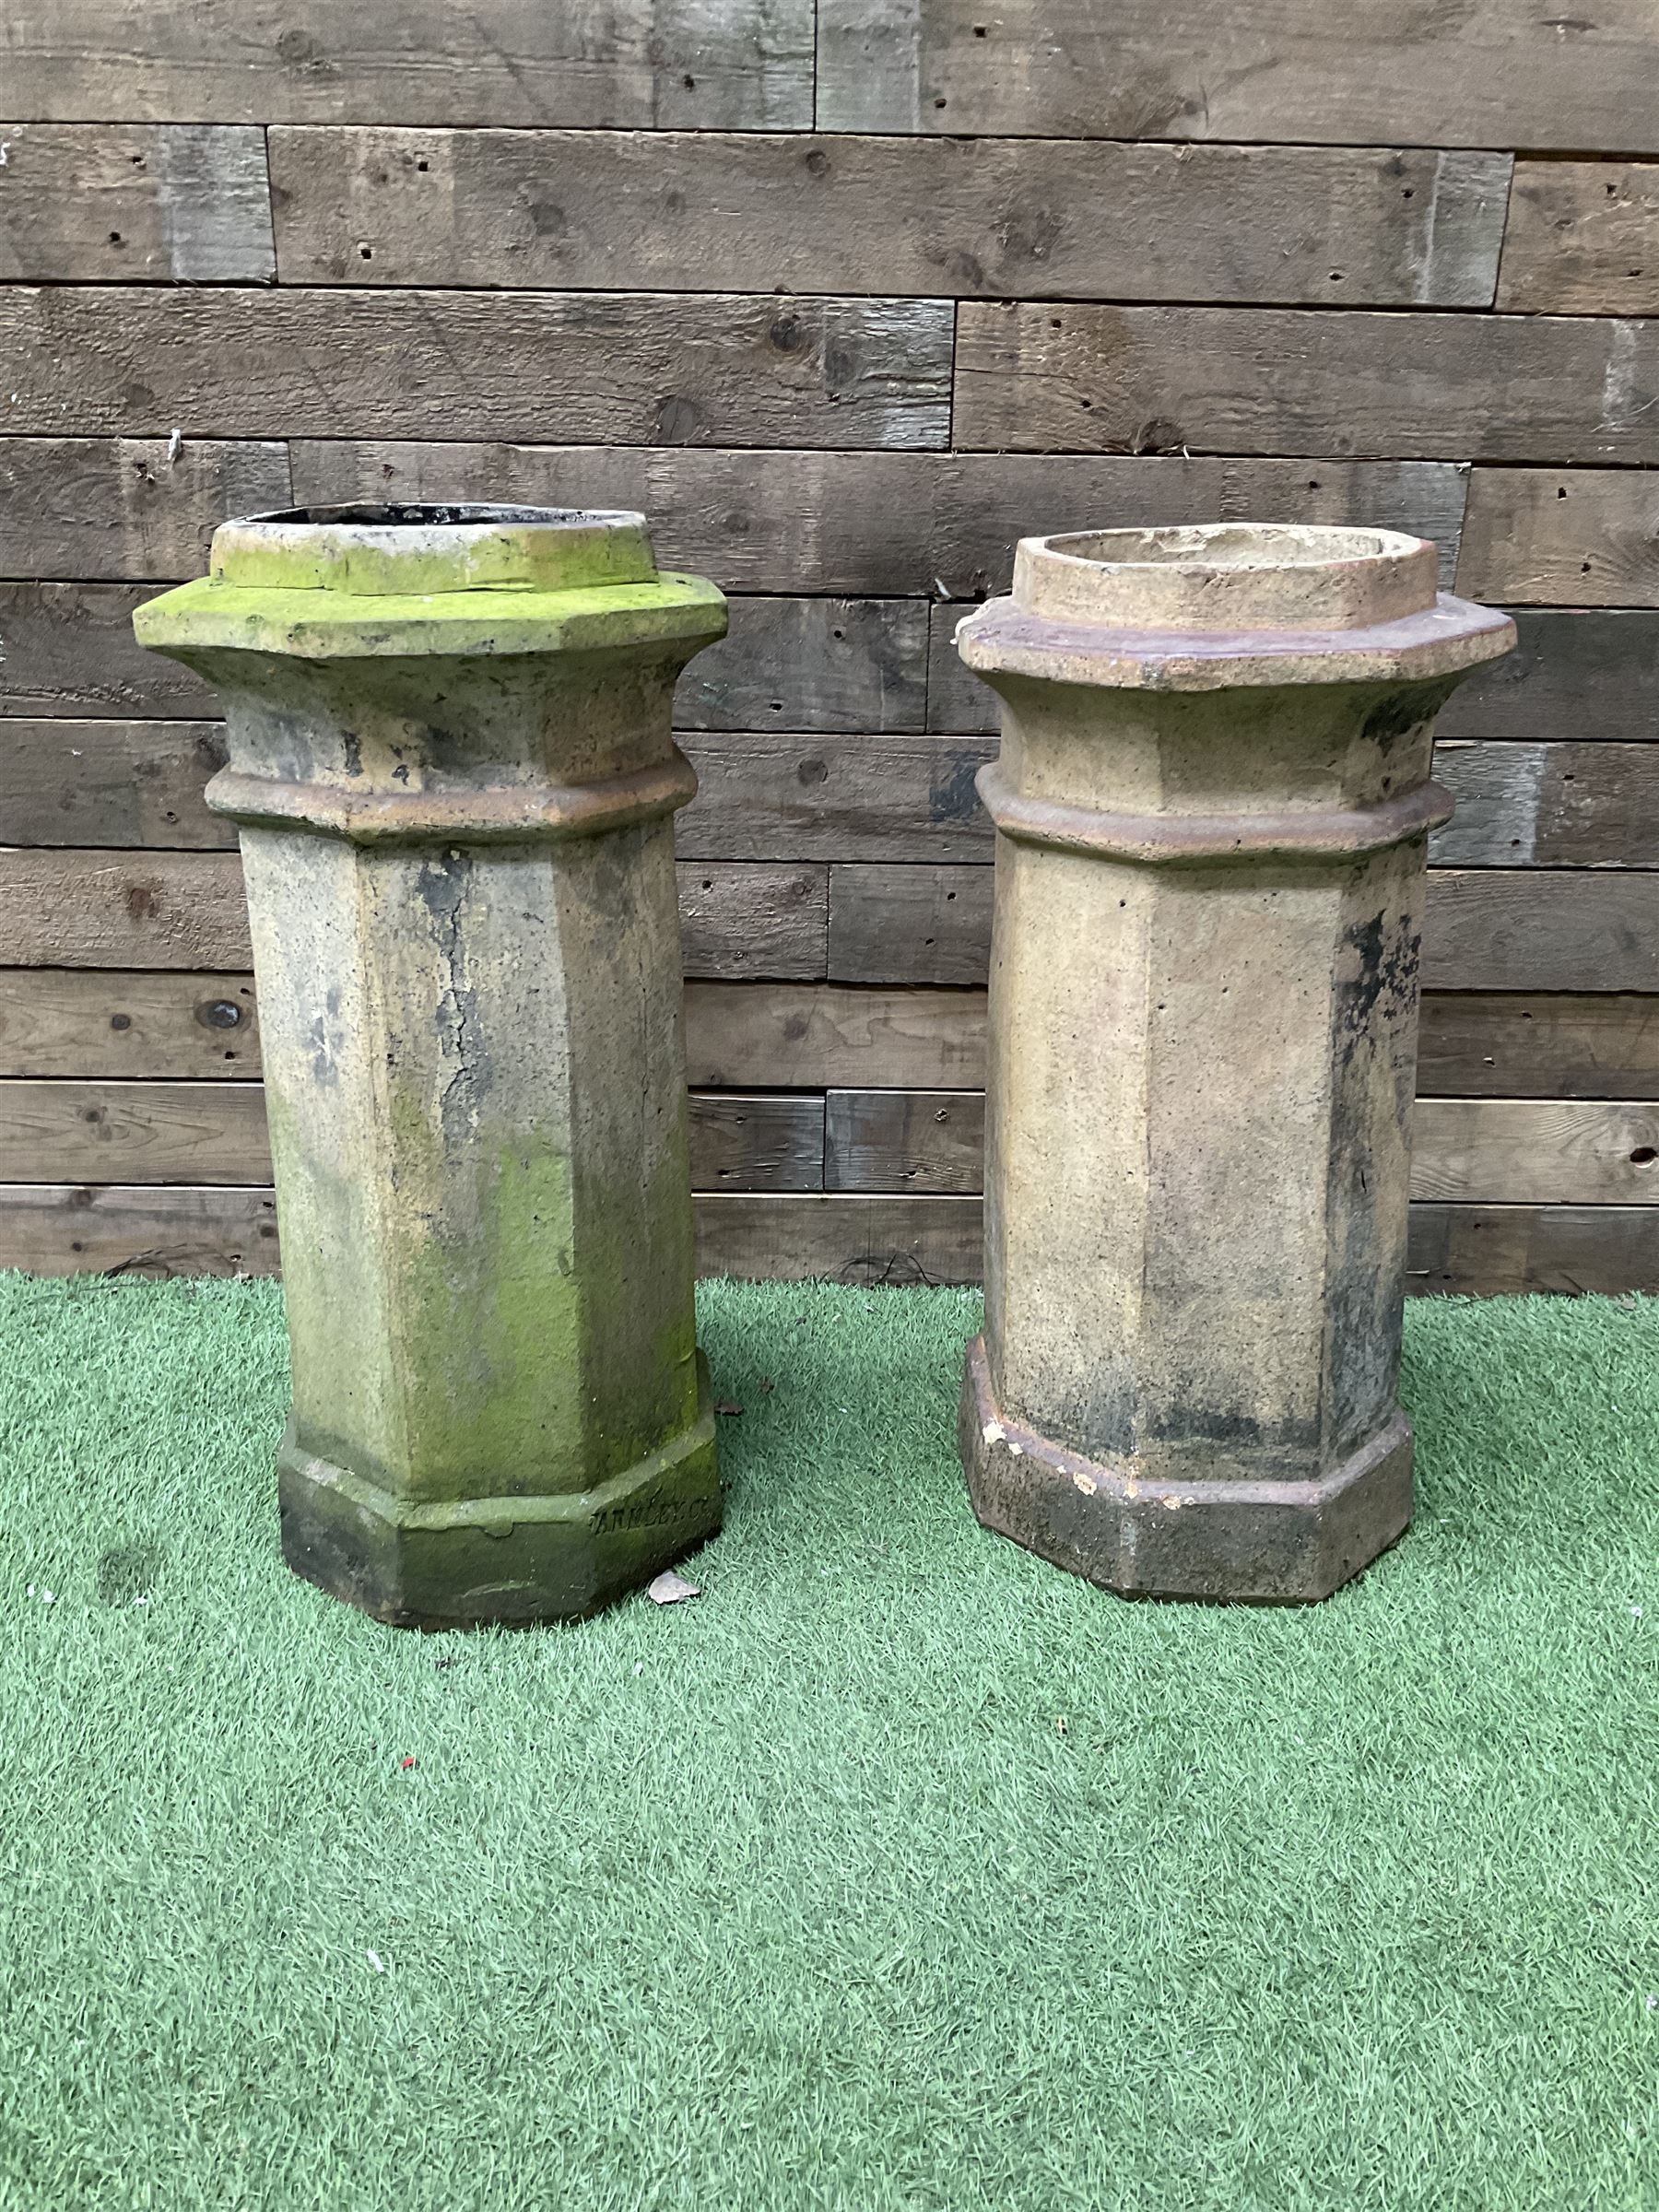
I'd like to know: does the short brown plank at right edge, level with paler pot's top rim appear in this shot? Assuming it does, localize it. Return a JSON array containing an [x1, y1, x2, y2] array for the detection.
[[1458, 473, 1659, 606]]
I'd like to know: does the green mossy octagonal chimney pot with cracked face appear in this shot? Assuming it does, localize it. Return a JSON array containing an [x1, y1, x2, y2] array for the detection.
[[135, 504, 725, 1628]]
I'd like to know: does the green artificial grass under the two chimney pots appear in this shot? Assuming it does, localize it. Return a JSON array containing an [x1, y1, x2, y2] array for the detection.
[[0, 1277, 1659, 2212]]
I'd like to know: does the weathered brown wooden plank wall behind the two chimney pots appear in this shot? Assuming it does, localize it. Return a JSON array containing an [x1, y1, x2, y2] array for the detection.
[[0, 0, 1659, 1292]]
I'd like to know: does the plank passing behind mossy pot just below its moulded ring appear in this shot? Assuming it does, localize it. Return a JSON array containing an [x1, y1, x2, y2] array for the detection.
[[0, 847, 828, 978]]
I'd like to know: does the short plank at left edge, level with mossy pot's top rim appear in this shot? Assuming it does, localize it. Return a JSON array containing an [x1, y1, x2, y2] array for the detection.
[[0, 435, 292, 582]]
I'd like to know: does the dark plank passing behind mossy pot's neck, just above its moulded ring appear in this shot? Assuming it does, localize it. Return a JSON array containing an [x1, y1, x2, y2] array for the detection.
[[0, 584, 929, 734]]
